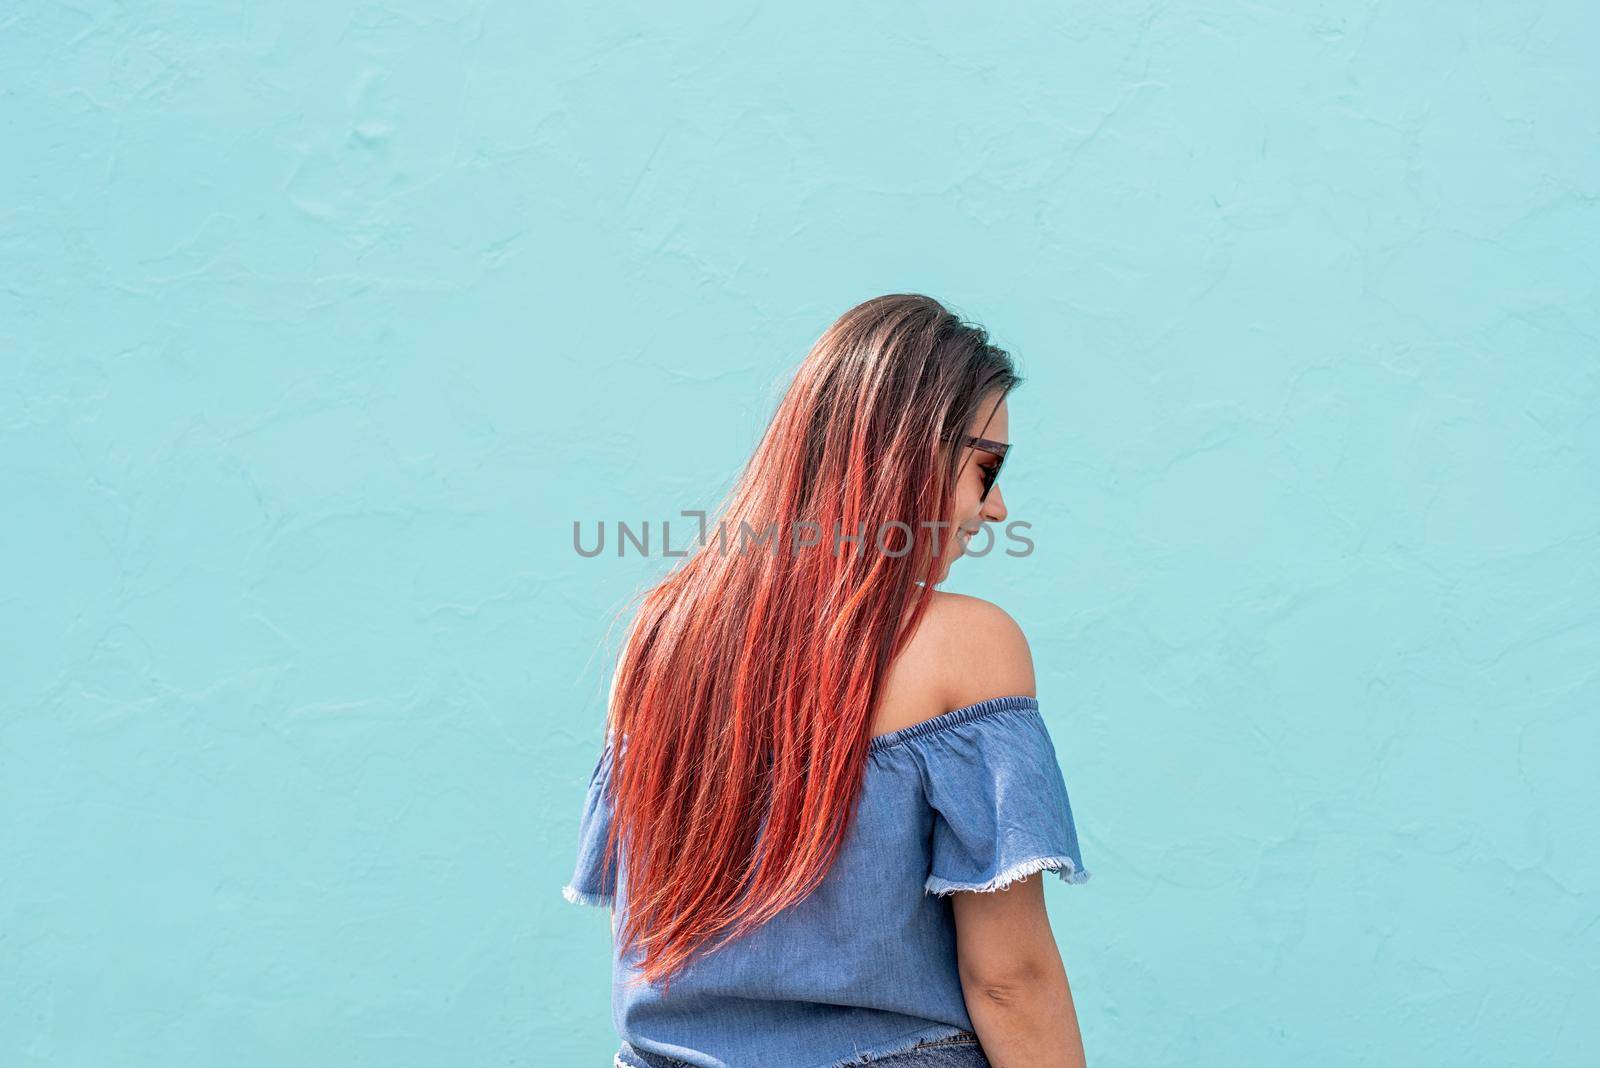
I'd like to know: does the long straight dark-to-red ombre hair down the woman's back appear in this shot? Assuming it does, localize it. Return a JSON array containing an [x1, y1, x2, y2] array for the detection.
[[606, 294, 1021, 983]]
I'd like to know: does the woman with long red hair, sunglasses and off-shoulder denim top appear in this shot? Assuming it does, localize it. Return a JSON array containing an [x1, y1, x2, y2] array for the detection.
[[563, 294, 1088, 1068]]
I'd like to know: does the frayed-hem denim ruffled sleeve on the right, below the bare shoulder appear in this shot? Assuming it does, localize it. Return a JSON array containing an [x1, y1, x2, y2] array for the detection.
[[912, 695, 1090, 895]]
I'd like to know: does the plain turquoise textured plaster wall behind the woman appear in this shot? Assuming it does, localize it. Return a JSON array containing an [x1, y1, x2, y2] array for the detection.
[[0, 0, 1600, 1068]]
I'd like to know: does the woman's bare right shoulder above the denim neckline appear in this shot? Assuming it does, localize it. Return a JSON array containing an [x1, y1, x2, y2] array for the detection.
[[872, 590, 1035, 734]]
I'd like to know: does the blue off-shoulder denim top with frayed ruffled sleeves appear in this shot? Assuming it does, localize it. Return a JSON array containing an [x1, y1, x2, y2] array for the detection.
[[562, 695, 1090, 1068]]
